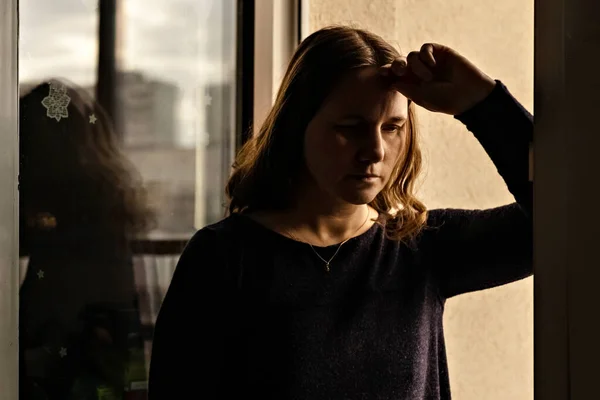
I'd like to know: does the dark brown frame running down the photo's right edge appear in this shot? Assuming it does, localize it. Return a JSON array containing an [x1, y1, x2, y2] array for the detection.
[[533, 0, 600, 400]]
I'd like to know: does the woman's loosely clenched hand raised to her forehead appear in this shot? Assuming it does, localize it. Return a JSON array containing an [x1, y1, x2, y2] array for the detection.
[[381, 43, 496, 115]]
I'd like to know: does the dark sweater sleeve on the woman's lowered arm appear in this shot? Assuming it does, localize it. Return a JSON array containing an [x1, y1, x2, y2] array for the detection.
[[148, 228, 229, 400]]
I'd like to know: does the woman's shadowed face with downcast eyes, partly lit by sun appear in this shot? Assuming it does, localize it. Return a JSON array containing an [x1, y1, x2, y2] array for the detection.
[[304, 67, 408, 204]]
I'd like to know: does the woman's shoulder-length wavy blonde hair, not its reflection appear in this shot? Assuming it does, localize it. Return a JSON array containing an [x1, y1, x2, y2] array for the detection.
[[226, 26, 427, 241]]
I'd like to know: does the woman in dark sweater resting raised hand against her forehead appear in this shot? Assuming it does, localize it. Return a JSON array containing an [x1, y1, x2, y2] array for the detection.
[[149, 27, 533, 400]]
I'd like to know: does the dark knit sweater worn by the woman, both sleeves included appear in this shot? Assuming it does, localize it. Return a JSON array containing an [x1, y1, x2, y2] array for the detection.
[[149, 82, 533, 400]]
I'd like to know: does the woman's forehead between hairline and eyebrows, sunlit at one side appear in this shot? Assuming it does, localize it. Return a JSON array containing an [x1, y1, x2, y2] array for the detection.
[[321, 67, 408, 120]]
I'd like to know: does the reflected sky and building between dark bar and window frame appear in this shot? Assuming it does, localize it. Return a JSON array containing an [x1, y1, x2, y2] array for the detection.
[[118, 0, 235, 235]]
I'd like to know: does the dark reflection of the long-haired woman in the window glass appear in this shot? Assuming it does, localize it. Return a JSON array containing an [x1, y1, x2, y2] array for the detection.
[[19, 80, 151, 400]]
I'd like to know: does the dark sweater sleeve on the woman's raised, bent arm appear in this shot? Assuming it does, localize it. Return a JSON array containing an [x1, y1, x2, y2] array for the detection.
[[429, 81, 533, 299]]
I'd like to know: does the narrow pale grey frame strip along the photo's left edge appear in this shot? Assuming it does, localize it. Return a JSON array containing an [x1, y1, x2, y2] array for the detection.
[[0, 0, 19, 400]]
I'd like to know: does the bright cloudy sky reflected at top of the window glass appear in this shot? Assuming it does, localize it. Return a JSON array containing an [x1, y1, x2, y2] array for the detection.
[[19, 0, 236, 145]]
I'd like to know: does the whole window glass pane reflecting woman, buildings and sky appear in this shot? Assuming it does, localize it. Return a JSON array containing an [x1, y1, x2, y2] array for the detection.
[[19, 0, 237, 400]]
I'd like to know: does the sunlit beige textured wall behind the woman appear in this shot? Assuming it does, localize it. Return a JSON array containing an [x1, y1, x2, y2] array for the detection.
[[310, 0, 533, 400]]
